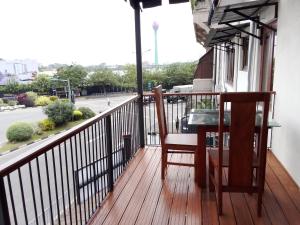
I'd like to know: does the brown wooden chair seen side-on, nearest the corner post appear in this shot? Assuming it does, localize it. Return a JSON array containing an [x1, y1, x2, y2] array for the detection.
[[154, 85, 197, 179]]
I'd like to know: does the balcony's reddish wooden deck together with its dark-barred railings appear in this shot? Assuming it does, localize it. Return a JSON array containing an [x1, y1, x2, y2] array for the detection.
[[0, 93, 300, 225]]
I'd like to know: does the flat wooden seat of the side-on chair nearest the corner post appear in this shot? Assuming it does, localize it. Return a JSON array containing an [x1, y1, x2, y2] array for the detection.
[[165, 134, 197, 147]]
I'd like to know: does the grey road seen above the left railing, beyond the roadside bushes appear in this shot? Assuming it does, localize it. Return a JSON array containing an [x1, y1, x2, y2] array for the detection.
[[0, 94, 131, 145]]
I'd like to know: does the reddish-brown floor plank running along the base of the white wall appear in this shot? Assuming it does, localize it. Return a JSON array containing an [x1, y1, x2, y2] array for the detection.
[[267, 151, 300, 212]]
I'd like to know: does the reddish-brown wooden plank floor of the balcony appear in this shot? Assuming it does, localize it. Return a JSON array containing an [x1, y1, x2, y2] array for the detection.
[[90, 147, 300, 225]]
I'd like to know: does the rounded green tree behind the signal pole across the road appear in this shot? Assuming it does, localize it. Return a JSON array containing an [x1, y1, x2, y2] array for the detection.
[[55, 65, 87, 88]]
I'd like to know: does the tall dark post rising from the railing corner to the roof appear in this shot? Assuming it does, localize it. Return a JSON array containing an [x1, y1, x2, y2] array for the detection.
[[134, 1, 145, 148]]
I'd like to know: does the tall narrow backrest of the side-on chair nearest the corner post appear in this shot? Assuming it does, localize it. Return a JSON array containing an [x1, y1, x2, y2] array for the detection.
[[154, 85, 168, 144]]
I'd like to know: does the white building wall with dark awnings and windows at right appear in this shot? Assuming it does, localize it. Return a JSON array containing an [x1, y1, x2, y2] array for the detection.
[[193, 0, 300, 186]]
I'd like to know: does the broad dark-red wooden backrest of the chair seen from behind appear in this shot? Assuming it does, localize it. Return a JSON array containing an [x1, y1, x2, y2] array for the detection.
[[219, 92, 270, 188]]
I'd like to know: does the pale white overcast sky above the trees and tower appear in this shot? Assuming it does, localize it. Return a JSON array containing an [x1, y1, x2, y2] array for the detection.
[[0, 0, 205, 65]]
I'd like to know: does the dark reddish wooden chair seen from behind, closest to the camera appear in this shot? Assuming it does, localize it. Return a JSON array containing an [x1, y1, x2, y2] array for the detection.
[[208, 92, 270, 216]]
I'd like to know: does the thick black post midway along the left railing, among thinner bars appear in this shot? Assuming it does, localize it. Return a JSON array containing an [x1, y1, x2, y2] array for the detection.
[[106, 115, 114, 191]]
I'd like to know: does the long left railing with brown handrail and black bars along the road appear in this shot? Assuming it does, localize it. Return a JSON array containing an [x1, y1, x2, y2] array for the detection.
[[0, 96, 139, 225]]
